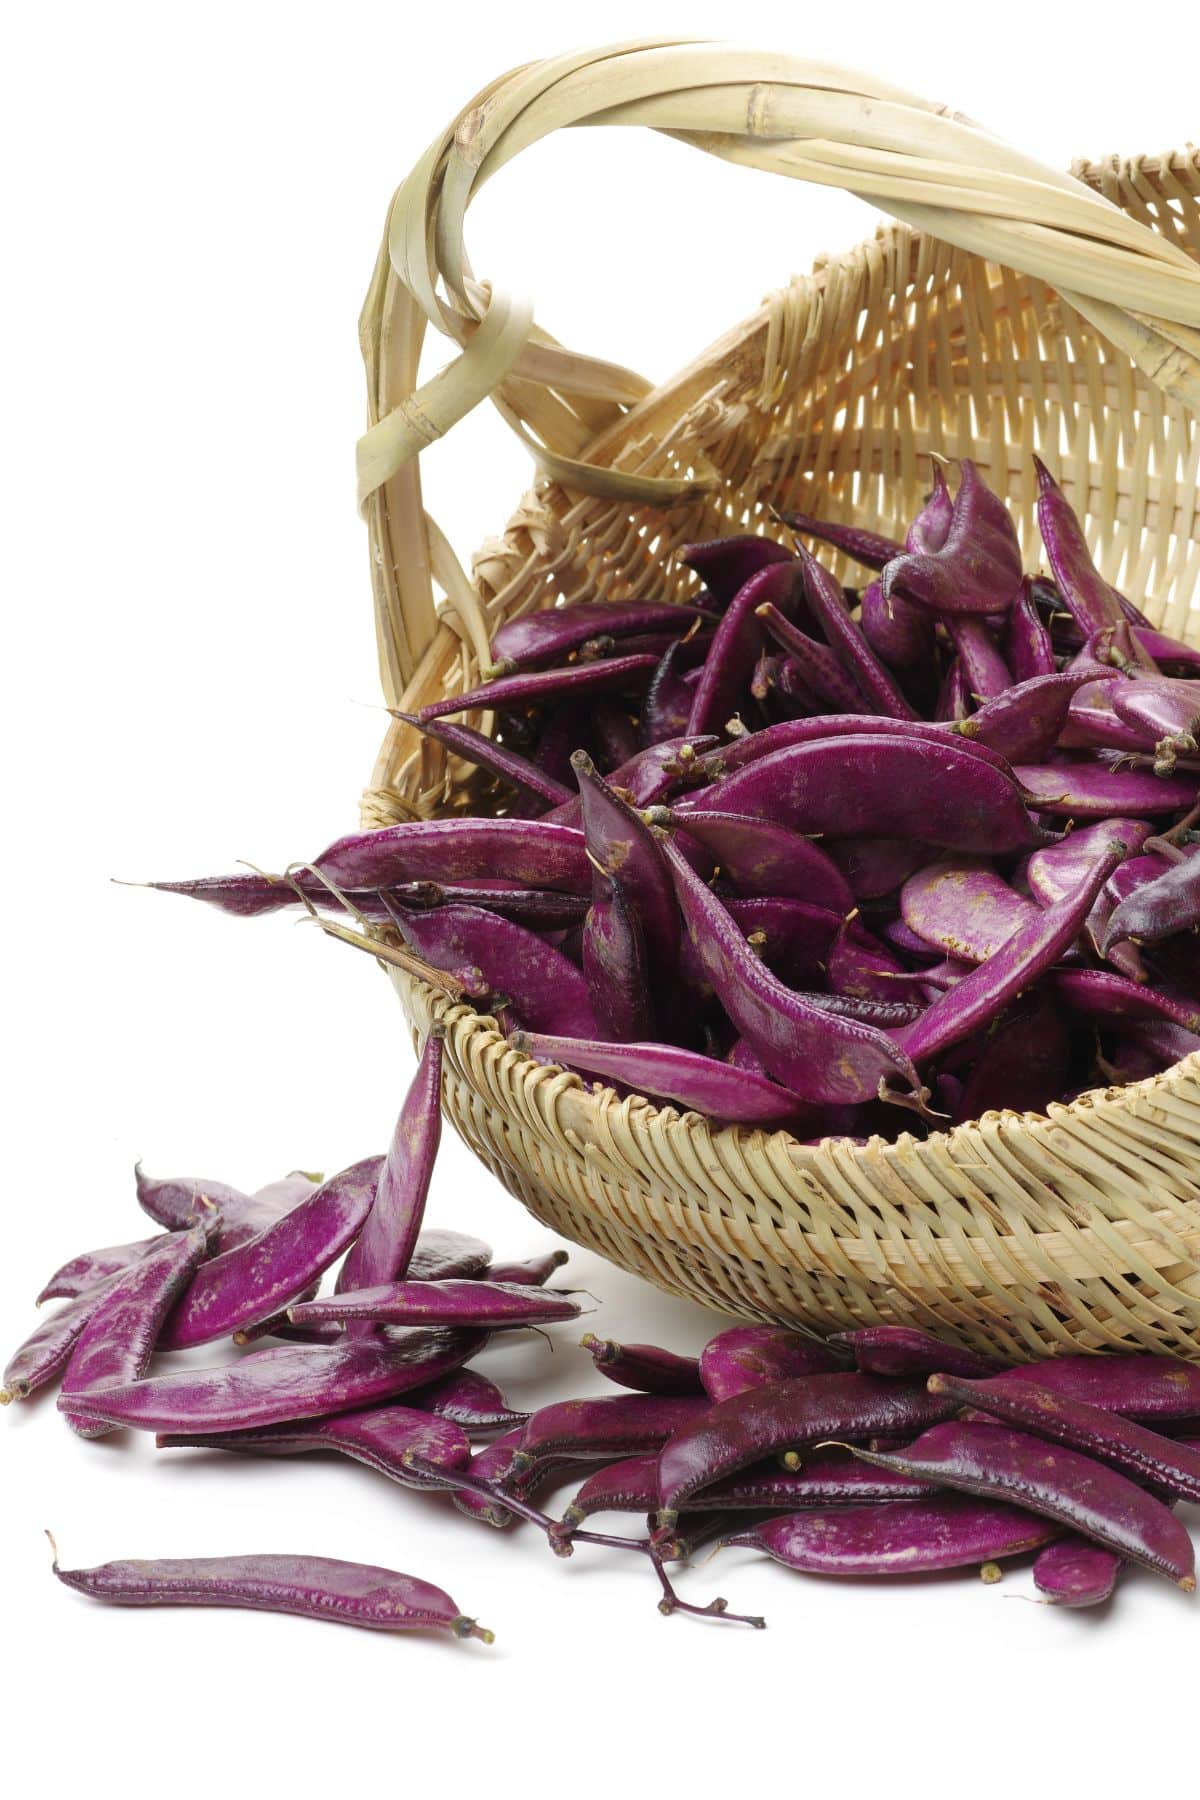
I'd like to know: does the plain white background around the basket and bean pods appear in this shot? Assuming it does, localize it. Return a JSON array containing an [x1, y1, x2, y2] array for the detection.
[[0, 0, 1200, 1800]]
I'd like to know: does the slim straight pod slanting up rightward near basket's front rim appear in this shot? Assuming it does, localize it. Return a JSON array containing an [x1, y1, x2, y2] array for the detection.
[[896, 832, 1132, 1062]]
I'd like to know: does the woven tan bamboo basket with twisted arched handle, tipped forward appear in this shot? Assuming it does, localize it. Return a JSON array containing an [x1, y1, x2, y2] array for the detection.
[[349, 40, 1200, 1361]]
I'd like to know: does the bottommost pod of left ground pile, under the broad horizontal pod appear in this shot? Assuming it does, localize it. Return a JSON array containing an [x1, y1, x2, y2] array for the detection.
[[157, 1406, 471, 1487]]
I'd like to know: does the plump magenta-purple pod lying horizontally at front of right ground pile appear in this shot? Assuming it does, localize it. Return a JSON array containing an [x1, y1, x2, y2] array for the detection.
[[723, 1498, 1060, 1575]]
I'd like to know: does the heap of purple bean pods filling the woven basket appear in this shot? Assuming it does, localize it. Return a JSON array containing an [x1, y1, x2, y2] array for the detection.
[[158, 461, 1200, 1143]]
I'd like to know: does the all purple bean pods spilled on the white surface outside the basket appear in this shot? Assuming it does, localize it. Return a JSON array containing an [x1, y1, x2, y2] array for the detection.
[[2, 1031, 1200, 1642]]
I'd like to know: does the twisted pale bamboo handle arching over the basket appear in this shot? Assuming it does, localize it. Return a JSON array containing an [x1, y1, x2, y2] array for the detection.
[[358, 38, 1200, 706]]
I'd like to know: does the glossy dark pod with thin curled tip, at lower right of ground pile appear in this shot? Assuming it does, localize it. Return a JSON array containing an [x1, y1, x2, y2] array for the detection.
[[851, 1422, 1196, 1593]]
